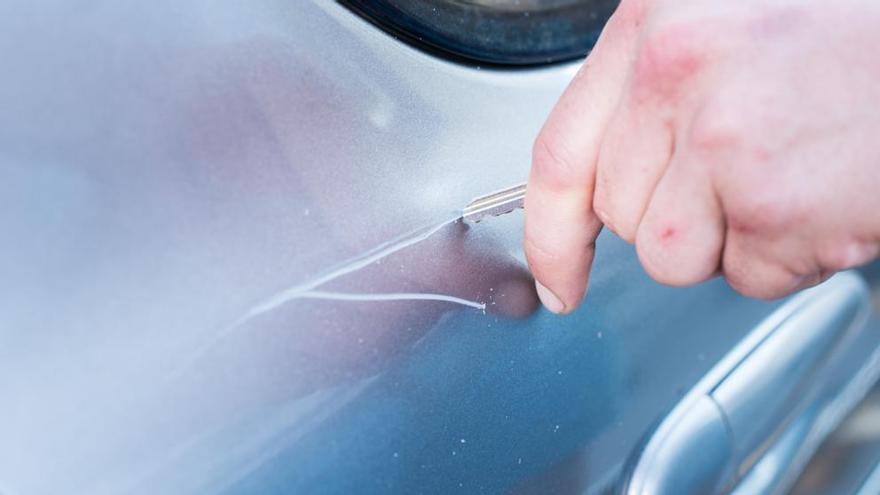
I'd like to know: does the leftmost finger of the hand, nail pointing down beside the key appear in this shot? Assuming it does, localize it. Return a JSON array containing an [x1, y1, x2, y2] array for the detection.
[[524, 1, 641, 314]]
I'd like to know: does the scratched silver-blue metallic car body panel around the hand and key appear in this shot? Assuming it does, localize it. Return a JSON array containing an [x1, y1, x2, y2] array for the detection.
[[0, 0, 775, 495]]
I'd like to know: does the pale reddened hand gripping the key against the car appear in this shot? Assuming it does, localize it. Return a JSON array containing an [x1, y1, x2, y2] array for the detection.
[[525, 0, 880, 314]]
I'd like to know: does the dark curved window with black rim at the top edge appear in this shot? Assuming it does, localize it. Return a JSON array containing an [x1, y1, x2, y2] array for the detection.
[[343, 0, 619, 65]]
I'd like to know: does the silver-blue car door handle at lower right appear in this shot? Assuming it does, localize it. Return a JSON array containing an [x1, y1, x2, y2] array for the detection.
[[624, 273, 870, 495]]
